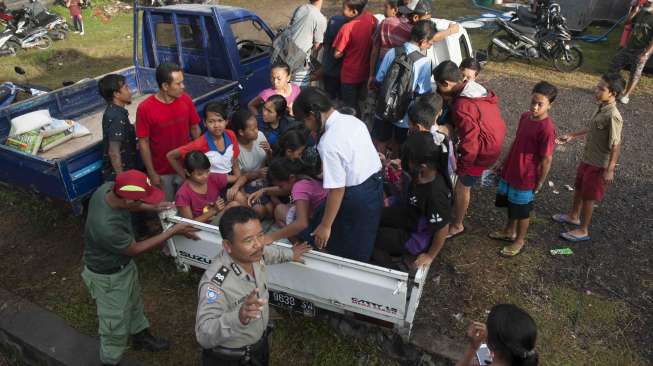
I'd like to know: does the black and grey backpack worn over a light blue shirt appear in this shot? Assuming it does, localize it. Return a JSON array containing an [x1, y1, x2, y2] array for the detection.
[[376, 46, 424, 123]]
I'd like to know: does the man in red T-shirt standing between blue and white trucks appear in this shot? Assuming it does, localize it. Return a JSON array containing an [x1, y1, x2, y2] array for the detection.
[[136, 62, 201, 201]]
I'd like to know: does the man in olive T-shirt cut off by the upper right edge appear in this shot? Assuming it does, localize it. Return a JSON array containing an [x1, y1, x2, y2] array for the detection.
[[609, 0, 653, 104]]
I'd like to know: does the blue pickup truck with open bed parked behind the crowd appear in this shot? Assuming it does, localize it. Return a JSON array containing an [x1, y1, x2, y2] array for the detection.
[[0, 4, 274, 214]]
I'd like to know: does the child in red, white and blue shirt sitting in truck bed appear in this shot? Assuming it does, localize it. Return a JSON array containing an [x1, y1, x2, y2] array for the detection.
[[166, 102, 247, 205]]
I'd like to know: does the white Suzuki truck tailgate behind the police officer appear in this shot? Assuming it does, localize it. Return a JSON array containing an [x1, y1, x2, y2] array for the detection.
[[162, 213, 428, 336]]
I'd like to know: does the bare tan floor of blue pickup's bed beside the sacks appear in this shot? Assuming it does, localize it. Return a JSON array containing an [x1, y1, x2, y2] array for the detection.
[[39, 94, 151, 160]]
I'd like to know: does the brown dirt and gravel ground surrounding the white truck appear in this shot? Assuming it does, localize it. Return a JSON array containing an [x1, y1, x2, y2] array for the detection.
[[0, 0, 653, 365]]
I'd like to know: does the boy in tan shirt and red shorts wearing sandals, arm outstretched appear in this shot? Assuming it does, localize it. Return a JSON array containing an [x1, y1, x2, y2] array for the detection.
[[553, 74, 626, 242]]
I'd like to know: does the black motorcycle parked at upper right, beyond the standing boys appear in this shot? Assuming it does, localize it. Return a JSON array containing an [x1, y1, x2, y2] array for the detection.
[[488, 3, 583, 72]]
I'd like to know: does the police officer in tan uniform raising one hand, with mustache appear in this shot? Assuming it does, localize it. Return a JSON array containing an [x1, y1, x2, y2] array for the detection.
[[195, 207, 310, 366]]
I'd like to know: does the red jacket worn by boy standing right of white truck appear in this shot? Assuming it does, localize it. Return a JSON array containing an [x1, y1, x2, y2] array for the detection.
[[452, 82, 506, 176]]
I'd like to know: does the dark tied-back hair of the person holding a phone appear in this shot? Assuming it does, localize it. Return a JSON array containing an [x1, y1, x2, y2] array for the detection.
[[487, 304, 539, 366]]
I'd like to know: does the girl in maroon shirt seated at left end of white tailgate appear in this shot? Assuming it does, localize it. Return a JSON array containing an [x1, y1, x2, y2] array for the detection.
[[175, 151, 238, 222]]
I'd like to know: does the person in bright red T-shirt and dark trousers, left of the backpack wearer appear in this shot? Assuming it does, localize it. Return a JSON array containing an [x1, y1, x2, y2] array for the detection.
[[333, 0, 377, 116]]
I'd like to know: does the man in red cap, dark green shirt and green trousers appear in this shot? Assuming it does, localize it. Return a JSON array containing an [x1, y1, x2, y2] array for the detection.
[[82, 170, 194, 365]]
